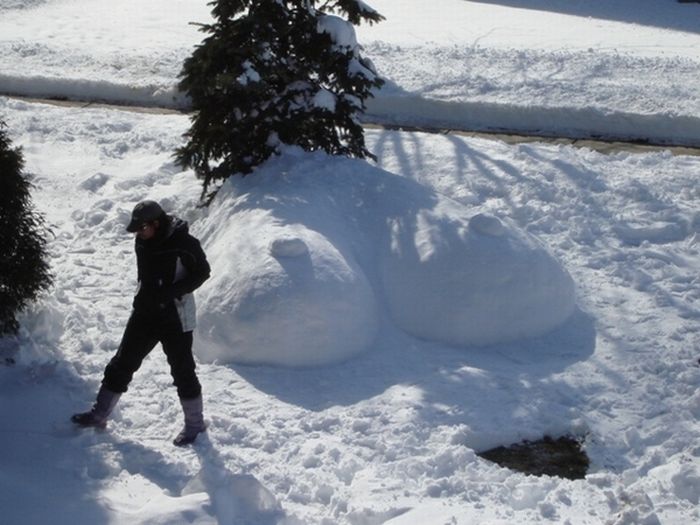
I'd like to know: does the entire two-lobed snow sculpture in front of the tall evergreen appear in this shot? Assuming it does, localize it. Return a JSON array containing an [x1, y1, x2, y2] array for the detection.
[[193, 149, 574, 366]]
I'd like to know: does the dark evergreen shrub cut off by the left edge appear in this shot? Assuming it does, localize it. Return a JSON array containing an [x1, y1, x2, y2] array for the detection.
[[0, 121, 51, 335]]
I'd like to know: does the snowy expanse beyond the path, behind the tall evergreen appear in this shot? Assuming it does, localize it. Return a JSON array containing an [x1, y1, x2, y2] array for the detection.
[[0, 0, 700, 146]]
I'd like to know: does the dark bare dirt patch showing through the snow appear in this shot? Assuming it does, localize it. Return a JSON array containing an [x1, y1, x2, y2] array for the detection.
[[479, 436, 590, 479]]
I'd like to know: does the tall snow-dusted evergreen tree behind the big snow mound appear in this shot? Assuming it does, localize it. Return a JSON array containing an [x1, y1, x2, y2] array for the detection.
[[176, 0, 383, 204]]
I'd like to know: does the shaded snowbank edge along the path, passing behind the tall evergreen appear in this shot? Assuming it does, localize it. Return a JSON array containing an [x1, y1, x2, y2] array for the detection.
[[5, 74, 700, 147]]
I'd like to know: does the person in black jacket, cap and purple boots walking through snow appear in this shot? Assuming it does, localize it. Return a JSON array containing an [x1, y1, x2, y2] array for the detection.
[[71, 200, 210, 446]]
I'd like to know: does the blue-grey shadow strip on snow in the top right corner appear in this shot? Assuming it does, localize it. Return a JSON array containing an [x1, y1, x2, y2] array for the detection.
[[467, 0, 700, 33]]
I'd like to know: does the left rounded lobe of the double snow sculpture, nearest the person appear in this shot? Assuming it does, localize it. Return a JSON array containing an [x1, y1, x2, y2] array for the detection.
[[196, 202, 377, 367]]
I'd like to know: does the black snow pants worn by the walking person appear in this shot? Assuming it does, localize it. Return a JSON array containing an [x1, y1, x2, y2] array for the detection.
[[102, 307, 202, 399]]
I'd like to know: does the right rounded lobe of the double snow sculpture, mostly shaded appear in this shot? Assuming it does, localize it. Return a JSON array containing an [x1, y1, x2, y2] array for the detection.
[[382, 205, 575, 346]]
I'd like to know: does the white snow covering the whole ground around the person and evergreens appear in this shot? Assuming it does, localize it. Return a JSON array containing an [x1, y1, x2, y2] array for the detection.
[[0, 0, 700, 525]]
